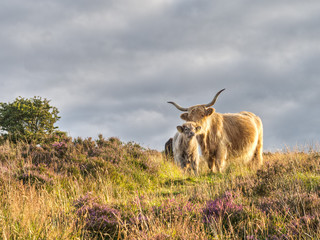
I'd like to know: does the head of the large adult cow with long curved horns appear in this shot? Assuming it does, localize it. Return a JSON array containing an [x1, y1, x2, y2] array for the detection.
[[168, 89, 225, 123]]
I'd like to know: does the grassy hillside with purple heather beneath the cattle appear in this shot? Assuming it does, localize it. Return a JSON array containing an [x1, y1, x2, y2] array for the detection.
[[0, 136, 320, 240]]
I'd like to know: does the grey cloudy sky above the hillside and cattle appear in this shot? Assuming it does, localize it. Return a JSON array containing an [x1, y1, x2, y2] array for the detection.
[[0, 0, 320, 150]]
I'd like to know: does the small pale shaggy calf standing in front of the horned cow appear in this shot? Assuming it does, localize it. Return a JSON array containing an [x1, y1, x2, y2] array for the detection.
[[172, 122, 201, 174]]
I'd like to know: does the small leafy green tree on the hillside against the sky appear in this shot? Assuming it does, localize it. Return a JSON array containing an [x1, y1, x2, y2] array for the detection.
[[0, 97, 60, 143]]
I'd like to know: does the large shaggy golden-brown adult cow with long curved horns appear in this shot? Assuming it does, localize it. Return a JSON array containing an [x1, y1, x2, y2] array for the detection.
[[168, 89, 263, 172]]
